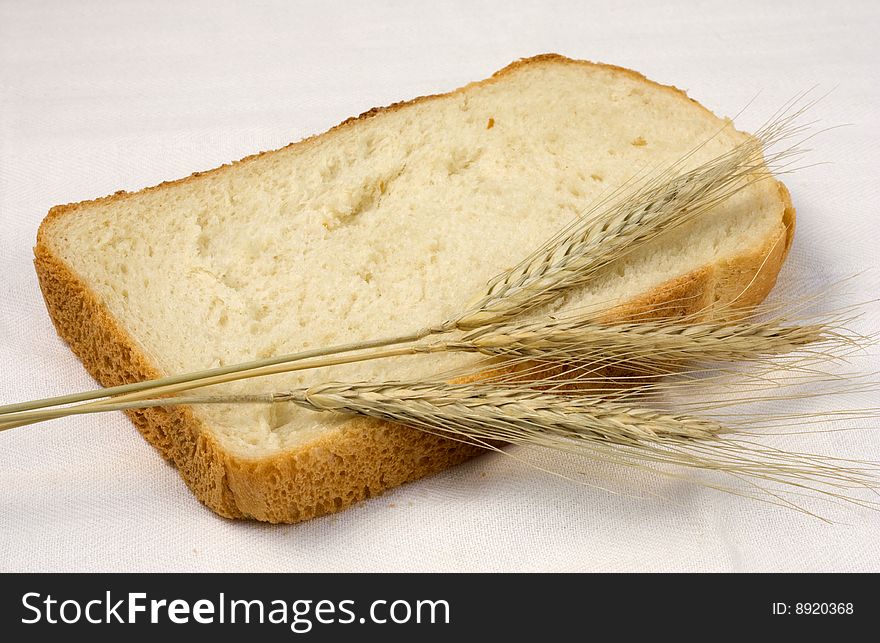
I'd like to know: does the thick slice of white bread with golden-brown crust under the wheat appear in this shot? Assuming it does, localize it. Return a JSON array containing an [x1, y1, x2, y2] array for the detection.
[[35, 55, 794, 522]]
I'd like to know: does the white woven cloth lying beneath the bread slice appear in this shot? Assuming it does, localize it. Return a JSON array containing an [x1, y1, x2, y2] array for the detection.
[[0, 0, 880, 571]]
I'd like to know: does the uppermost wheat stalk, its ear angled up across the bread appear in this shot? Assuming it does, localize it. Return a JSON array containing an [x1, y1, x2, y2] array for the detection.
[[0, 110, 803, 421]]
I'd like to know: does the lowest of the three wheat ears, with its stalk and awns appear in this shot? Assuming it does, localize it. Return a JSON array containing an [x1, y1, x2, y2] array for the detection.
[[6, 382, 878, 515]]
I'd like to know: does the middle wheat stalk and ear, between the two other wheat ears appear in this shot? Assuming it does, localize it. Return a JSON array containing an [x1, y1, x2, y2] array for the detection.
[[0, 308, 855, 430]]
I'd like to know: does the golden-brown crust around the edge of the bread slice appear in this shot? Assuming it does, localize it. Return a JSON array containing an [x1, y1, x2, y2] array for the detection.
[[34, 54, 795, 523]]
